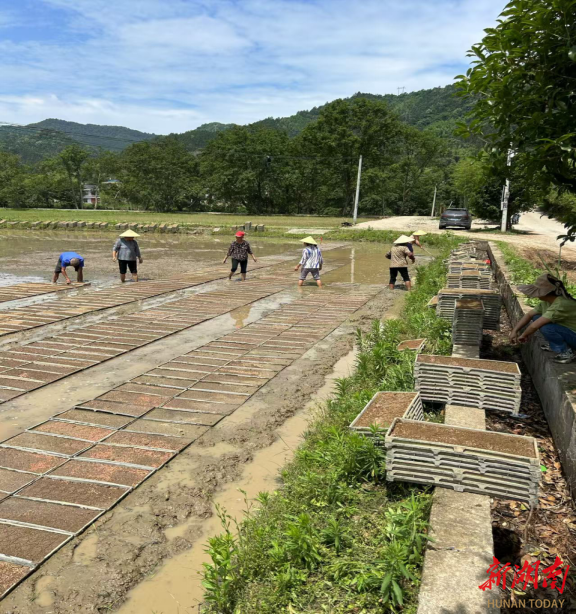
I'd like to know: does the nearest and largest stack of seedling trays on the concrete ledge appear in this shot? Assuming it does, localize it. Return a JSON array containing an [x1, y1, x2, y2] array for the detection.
[[385, 418, 540, 513]]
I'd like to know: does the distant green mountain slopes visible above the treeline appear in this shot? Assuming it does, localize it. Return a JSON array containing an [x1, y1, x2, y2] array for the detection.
[[0, 85, 473, 164]]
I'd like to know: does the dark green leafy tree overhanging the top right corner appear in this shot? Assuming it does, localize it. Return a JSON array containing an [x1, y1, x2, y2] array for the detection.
[[459, 0, 576, 231]]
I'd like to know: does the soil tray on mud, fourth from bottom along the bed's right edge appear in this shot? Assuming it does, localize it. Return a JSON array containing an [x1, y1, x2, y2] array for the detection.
[[18, 478, 127, 509]]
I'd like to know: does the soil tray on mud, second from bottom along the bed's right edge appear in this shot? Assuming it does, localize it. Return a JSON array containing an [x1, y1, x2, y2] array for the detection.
[[0, 524, 69, 564]]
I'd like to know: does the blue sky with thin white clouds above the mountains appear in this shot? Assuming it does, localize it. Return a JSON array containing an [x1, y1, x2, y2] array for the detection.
[[0, 0, 505, 134]]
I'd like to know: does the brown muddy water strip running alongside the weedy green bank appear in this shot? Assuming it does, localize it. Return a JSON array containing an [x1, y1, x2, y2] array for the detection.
[[117, 350, 356, 614]]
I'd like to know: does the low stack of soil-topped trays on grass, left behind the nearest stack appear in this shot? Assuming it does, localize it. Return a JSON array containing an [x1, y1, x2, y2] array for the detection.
[[350, 392, 424, 444]]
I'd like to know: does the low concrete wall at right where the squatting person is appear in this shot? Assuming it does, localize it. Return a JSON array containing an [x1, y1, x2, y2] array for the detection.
[[488, 243, 576, 498]]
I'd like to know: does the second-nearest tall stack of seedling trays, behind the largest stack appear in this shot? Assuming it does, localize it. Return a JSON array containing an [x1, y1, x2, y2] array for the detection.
[[414, 354, 522, 416]]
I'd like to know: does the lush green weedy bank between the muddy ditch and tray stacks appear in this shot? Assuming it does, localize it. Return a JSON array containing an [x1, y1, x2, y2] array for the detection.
[[203, 237, 457, 614]]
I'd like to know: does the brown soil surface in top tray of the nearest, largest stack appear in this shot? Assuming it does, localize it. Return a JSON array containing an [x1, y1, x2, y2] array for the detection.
[[388, 420, 536, 458]]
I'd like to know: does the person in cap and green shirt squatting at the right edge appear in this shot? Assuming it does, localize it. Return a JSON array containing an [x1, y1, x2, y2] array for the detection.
[[510, 273, 576, 364]]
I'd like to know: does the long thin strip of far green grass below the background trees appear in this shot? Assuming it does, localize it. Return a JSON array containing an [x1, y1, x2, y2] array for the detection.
[[0, 209, 374, 228]]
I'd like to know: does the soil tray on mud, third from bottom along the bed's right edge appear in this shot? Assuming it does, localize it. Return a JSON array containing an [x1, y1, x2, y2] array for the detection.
[[0, 497, 101, 533]]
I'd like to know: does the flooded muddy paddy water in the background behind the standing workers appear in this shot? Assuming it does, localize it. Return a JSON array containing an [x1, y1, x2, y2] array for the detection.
[[0, 230, 423, 286]]
